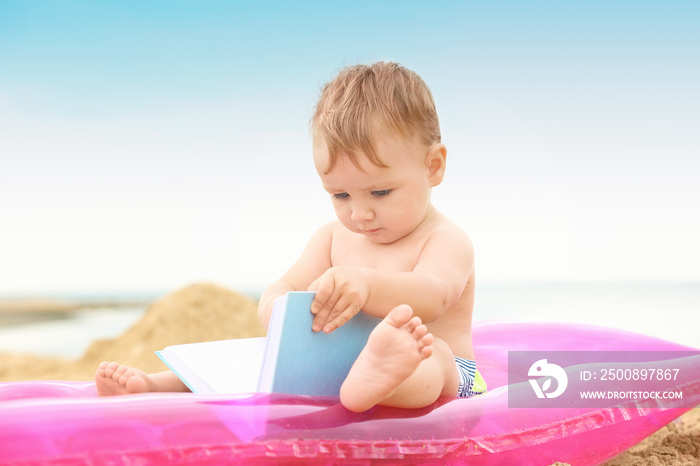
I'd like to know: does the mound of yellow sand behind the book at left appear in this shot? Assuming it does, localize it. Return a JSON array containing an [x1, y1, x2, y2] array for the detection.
[[0, 284, 265, 381]]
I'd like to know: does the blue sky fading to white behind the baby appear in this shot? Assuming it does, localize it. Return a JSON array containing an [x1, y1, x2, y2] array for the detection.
[[0, 0, 700, 296]]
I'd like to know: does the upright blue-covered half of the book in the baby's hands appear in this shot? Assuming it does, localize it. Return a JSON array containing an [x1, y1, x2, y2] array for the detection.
[[258, 291, 381, 396]]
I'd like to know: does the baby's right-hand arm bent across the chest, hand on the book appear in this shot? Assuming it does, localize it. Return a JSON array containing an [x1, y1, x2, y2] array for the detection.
[[311, 224, 474, 332]]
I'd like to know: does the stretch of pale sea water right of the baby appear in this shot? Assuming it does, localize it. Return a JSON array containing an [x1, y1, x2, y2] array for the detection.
[[474, 283, 700, 348]]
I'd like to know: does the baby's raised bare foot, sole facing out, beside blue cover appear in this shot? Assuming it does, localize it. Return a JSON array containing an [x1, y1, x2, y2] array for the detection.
[[340, 305, 433, 412]]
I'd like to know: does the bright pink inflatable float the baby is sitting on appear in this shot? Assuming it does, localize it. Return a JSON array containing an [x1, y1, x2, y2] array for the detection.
[[0, 322, 700, 465]]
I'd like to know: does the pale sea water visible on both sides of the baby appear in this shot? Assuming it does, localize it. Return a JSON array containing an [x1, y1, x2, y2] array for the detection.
[[0, 283, 700, 358]]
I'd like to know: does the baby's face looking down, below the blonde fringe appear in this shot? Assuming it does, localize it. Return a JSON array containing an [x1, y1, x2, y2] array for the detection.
[[314, 137, 431, 244]]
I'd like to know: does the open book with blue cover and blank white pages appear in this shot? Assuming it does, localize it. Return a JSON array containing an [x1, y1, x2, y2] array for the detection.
[[156, 292, 380, 396]]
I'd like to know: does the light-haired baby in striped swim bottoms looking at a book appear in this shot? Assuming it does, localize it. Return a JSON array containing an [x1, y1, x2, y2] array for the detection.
[[96, 62, 486, 412]]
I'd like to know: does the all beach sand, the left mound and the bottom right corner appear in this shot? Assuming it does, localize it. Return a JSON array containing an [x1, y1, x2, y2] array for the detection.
[[0, 284, 700, 466]]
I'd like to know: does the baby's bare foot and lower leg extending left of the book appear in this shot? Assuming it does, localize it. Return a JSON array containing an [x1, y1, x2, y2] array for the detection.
[[95, 361, 189, 396]]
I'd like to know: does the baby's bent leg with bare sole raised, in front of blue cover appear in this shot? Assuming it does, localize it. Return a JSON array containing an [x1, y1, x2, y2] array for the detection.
[[340, 305, 459, 412]]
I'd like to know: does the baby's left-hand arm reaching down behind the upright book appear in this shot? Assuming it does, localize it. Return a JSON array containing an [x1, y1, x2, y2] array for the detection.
[[258, 224, 331, 328]]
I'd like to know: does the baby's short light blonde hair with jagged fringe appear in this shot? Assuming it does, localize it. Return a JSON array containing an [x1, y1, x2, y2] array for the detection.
[[311, 62, 440, 173]]
